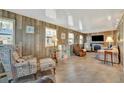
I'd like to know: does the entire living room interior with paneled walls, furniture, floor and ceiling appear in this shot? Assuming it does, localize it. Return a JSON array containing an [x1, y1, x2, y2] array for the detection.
[[0, 9, 124, 83]]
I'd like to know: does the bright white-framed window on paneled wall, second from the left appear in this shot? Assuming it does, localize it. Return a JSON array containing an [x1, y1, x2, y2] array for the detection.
[[45, 27, 57, 47]]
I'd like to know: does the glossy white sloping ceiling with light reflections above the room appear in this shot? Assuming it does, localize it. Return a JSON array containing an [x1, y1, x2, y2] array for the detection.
[[8, 9, 124, 33]]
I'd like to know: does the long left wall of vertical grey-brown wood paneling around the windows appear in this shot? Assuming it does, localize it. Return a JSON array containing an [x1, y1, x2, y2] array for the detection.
[[0, 10, 84, 58]]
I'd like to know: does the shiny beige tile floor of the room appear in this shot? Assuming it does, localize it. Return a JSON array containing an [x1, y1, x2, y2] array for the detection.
[[18, 52, 124, 83]]
